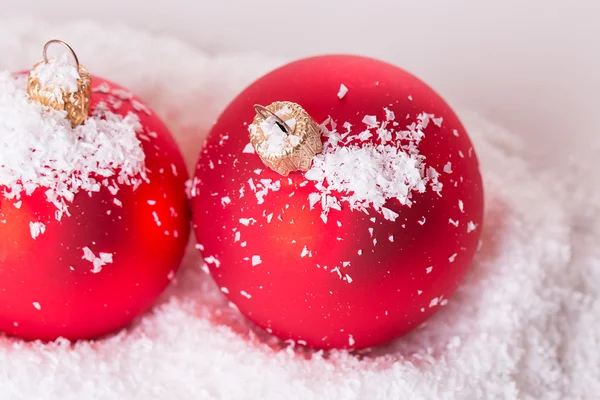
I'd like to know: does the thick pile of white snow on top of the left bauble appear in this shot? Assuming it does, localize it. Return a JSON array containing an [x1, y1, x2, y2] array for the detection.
[[0, 73, 146, 220]]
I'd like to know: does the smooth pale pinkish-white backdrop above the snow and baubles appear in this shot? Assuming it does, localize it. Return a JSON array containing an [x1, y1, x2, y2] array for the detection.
[[0, 0, 600, 164]]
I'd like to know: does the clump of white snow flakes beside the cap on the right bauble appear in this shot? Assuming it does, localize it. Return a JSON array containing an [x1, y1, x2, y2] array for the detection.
[[305, 109, 442, 222]]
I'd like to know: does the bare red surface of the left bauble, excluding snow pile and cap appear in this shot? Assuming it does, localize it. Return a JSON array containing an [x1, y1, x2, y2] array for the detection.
[[0, 77, 189, 340]]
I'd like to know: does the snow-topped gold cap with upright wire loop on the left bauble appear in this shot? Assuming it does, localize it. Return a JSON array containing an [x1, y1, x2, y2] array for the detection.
[[27, 40, 92, 127]]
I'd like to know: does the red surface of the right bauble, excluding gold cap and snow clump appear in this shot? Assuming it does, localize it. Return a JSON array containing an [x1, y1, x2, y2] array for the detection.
[[192, 56, 483, 349]]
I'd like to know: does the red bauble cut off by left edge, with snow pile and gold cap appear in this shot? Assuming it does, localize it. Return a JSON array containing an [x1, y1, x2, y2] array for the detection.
[[0, 40, 189, 340]]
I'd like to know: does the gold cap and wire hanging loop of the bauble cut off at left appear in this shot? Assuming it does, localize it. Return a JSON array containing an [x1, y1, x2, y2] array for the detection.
[[27, 39, 92, 127]]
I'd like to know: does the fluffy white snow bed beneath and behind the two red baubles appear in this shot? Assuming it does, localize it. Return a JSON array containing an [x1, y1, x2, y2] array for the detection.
[[0, 19, 600, 400]]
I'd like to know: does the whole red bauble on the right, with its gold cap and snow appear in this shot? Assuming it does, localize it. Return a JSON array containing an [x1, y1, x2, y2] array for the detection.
[[192, 56, 483, 349]]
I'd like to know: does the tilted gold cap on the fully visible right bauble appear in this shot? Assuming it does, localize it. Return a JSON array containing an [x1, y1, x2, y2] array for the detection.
[[250, 101, 323, 176]]
